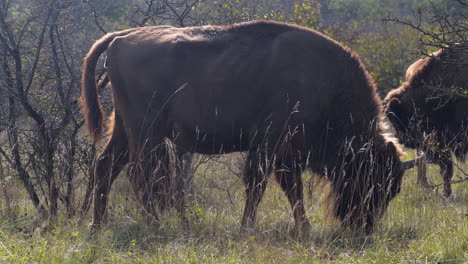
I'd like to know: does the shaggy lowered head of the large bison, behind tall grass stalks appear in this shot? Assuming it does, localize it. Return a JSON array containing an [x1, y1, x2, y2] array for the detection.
[[329, 142, 418, 232]]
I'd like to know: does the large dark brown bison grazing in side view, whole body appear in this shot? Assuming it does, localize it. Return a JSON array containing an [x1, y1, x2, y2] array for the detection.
[[82, 21, 415, 230]]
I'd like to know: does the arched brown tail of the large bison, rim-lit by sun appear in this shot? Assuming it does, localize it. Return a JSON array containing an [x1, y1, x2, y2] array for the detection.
[[80, 29, 136, 143]]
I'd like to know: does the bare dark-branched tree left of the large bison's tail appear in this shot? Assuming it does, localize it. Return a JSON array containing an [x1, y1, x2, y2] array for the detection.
[[0, 0, 96, 223]]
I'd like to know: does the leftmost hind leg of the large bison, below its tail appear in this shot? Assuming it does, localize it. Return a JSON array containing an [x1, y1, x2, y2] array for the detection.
[[93, 116, 128, 225]]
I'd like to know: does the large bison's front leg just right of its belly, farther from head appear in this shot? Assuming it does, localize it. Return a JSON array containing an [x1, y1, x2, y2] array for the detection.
[[241, 150, 271, 230]]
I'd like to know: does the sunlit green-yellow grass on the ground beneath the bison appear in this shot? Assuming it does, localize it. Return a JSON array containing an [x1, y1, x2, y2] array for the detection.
[[0, 152, 468, 263]]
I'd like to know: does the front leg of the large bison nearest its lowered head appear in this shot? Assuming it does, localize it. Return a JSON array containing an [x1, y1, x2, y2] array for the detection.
[[275, 158, 310, 232]]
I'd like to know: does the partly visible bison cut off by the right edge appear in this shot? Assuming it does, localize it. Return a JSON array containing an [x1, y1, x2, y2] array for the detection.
[[385, 44, 468, 197]]
